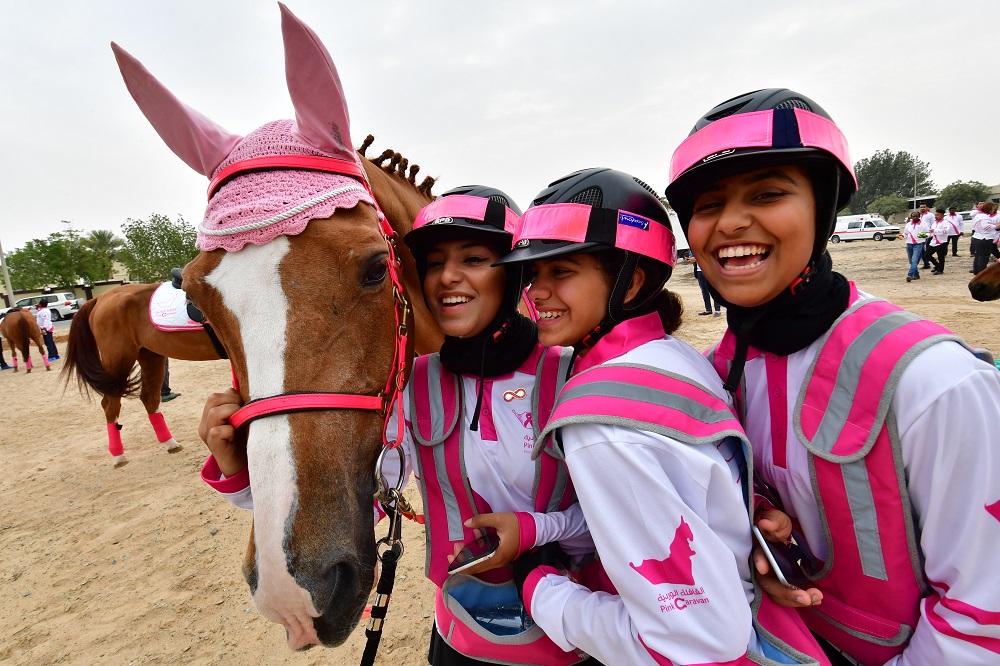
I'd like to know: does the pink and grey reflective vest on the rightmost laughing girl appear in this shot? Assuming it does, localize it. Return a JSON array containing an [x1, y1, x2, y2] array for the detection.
[[709, 294, 988, 664]]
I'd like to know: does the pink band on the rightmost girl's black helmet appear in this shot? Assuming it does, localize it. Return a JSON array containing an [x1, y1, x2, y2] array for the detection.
[[670, 108, 857, 185]]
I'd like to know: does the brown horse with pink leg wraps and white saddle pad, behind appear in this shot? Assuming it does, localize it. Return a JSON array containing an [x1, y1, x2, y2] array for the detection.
[[62, 284, 220, 467]]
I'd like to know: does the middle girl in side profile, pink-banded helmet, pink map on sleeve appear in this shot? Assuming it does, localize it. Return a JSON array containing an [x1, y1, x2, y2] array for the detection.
[[492, 169, 827, 664]]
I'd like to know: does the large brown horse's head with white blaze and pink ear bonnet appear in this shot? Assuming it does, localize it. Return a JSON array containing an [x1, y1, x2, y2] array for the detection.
[[111, 5, 442, 649]]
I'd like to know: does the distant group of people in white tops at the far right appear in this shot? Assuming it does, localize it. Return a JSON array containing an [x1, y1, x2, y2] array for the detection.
[[903, 201, 1000, 282]]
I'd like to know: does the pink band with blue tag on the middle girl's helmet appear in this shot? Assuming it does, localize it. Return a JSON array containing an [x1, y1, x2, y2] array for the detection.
[[514, 203, 677, 267]]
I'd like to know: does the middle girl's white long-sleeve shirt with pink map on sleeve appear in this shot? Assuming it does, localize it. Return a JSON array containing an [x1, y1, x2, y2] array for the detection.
[[525, 322, 780, 665]]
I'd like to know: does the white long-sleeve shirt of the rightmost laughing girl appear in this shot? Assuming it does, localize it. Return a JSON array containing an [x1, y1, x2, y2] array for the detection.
[[736, 294, 1000, 666]]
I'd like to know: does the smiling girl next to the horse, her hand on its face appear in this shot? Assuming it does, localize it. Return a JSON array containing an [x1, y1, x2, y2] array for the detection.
[[202, 186, 594, 666]]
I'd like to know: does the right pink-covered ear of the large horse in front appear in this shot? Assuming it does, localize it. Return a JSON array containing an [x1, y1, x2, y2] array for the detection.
[[278, 2, 358, 162]]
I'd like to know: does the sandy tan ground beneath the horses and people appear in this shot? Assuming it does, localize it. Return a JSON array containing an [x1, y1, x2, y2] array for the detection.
[[0, 241, 1000, 665]]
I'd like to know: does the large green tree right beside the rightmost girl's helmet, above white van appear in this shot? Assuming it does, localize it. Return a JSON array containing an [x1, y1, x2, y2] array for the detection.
[[851, 150, 934, 214]]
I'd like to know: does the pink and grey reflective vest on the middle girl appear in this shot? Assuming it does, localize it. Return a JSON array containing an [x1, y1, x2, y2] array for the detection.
[[535, 363, 829, 664]]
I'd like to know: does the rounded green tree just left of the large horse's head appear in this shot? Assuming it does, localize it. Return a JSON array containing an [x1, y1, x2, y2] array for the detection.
[[118, 213, 198, 282]]
